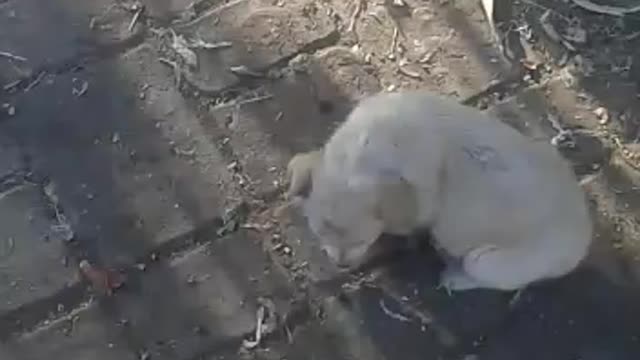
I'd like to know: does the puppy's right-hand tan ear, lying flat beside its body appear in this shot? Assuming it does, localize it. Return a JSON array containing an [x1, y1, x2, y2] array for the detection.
[[374, 172, 418, 235]]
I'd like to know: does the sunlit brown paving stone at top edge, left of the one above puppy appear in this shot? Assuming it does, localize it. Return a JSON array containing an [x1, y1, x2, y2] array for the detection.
[[174, 1, 336, 92]]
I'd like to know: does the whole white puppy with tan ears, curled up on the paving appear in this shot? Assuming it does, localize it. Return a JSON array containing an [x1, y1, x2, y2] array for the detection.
[[289, 92, 592, 290]]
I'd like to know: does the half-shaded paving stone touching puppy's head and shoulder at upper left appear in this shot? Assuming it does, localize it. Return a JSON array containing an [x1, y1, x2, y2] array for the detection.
[[212, 47, 380, 200]]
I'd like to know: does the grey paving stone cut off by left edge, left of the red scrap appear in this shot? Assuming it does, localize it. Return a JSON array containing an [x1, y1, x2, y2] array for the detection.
[[0, 185, 76, 314]]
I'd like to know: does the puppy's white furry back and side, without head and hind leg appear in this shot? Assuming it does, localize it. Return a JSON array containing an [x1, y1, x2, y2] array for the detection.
[[325, 91, 591, 256]]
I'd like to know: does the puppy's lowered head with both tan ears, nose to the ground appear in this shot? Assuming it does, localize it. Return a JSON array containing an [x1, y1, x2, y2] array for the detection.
[[288, 153, 416, 267]]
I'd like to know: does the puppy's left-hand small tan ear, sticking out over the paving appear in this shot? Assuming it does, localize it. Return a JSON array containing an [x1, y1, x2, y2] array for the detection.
[[285, 149, 322, 198]]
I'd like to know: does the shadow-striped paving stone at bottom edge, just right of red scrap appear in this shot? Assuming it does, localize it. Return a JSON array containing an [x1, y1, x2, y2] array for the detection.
[[6, 233, 291, 360]]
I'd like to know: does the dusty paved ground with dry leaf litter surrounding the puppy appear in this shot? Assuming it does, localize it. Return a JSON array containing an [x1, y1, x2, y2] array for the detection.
[[0, 0, 640, 360]]
